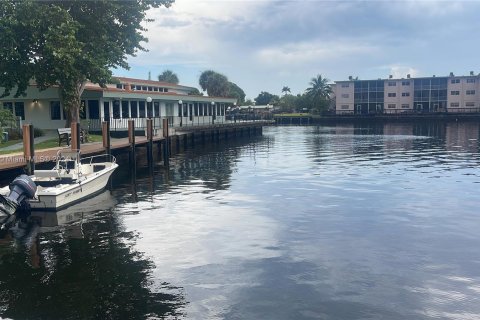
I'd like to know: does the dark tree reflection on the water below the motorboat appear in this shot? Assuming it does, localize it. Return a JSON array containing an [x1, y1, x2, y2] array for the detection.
[[0, 211, 185, 319]]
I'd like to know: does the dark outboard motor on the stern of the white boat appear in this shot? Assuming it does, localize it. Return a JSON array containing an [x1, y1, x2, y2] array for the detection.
[[0, 174, 37, 232]]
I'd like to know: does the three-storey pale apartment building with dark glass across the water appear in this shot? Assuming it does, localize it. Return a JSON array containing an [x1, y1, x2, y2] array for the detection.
[[333, 72, 480, 115]]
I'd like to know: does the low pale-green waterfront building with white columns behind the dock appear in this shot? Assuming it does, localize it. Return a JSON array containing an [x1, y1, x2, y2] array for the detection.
[[0, 77, 236, 130]]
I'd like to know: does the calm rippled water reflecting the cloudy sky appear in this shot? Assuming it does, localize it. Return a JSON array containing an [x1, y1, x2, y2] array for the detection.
[[0, 123, 480, 319]]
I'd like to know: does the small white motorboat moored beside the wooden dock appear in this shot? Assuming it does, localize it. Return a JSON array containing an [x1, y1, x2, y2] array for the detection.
[[0, 150, 118, 211]]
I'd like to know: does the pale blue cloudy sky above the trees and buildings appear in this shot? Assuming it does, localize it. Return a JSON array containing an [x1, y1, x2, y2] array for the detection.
[[114, 0, 480, 99]]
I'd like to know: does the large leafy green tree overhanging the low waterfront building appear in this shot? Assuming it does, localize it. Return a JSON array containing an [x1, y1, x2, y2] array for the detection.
[[0, 0, 174, 125]]
